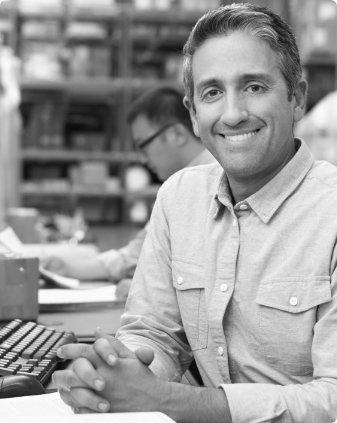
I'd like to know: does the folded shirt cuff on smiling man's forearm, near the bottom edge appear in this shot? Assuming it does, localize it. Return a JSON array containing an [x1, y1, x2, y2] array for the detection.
[[220, 383, 292, 423]]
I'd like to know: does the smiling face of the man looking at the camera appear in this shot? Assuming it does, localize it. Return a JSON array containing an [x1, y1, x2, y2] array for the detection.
[[185, 31, 303, 181]]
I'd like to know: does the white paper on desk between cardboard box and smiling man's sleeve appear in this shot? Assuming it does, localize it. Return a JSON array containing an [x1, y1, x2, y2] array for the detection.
[[38, 285, 116, 304]]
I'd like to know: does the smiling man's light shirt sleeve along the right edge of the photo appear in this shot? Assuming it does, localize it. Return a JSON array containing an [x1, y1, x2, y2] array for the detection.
[[221, 264, 337, 423]]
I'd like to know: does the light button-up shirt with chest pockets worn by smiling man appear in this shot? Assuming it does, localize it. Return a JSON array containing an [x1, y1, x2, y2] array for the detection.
[[118, 140, 337, 423]]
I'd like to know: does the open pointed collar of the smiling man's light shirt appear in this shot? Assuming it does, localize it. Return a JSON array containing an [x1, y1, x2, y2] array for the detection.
[[214, 138, 314, 223]]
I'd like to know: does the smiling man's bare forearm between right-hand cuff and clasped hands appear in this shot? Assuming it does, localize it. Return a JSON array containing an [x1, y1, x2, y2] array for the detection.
[[160, 383, 232, 423]]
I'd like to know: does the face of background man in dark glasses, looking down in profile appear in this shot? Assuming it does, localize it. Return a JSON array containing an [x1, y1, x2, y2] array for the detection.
[[131, 115, 181, 181]]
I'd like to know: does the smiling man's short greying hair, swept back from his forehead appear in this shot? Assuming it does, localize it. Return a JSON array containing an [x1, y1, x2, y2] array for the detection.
[[183, 3, 302, 104]]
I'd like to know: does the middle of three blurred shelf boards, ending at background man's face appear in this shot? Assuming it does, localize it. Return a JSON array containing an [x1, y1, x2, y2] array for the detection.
[[21, 148, 140, 163]]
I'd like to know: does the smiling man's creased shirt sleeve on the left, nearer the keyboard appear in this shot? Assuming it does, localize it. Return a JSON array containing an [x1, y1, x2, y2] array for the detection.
[[116, 187, 192, 381]]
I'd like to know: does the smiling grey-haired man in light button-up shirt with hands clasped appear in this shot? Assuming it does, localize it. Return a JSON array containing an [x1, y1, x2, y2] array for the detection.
[[54, 4, 337, 423]]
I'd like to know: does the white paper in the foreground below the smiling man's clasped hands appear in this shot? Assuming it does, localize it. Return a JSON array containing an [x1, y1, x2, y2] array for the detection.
[[0, 392, 173, 423]]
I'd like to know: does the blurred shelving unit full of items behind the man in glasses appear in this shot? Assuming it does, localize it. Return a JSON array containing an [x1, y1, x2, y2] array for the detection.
[[3, 0, 210, 223]]
